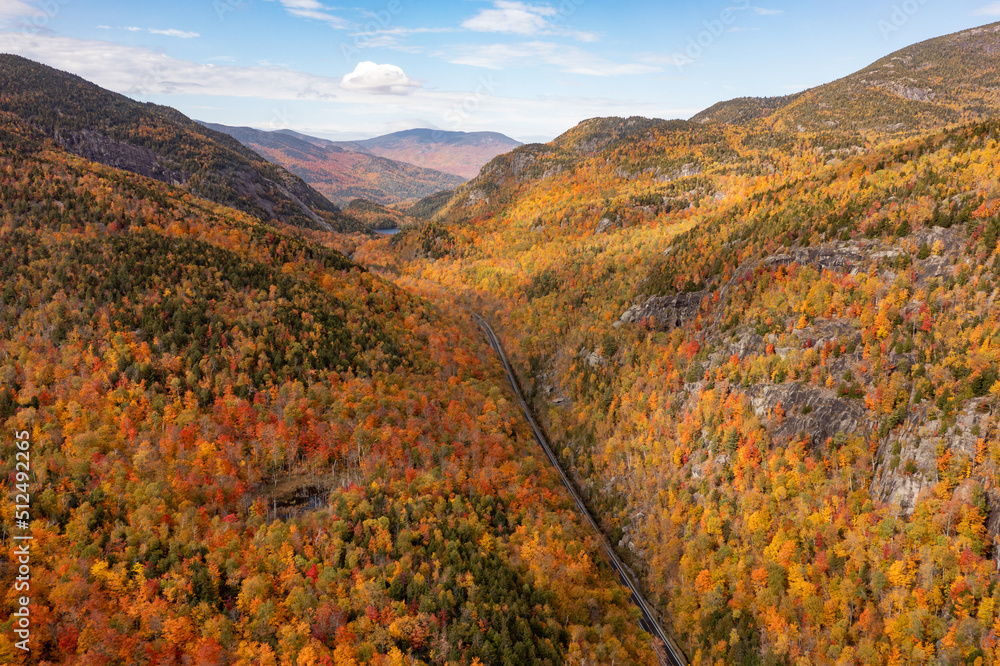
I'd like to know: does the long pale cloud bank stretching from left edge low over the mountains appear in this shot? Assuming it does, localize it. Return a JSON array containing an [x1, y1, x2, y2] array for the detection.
[[0, 32, 698, 143]]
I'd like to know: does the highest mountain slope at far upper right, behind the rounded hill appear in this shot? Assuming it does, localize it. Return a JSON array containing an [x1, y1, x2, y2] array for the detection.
[[692, 23, 1000, 134]]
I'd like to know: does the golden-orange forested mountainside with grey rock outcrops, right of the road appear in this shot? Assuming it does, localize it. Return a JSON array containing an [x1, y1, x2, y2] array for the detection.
[[355, 20, 1000, 664]]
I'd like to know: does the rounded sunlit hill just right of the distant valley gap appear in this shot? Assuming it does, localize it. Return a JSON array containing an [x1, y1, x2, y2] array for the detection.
[[415, 118, 740, 230]]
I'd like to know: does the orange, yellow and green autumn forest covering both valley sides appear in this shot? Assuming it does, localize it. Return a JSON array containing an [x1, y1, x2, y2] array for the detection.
[[0, 15, 1000, 666]]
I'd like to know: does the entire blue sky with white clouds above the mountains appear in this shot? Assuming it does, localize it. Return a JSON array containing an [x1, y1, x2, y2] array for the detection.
[[0, 0, 1000, 140]]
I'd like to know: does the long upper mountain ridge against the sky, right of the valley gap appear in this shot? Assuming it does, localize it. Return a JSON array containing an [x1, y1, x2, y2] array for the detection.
[[410, 22, 1000, 230]]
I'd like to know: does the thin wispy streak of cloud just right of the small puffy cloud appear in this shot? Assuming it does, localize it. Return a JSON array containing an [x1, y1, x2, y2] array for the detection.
[[448, 42, 660, 76]]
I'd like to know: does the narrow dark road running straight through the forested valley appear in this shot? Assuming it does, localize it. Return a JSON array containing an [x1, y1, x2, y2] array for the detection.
[[472, 313, 687, 666]]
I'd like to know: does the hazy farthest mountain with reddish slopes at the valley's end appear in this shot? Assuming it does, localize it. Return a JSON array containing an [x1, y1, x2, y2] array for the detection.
[[300, 129, 521, 179]]
